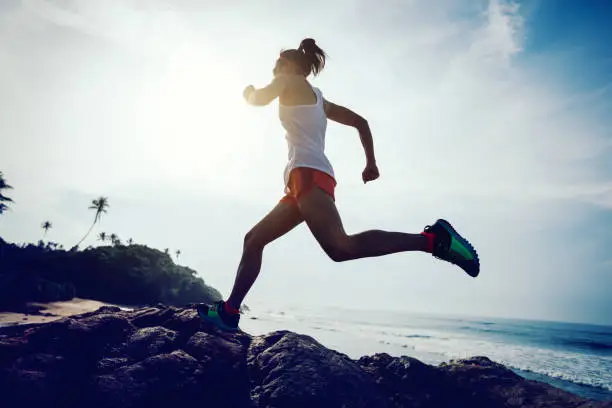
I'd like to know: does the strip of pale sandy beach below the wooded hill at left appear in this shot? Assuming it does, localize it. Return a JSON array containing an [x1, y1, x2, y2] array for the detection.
[[0, 298, 117, 326]]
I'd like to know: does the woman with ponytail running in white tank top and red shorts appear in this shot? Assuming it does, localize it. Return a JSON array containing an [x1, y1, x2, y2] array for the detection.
[[197, 38, 480, 330]]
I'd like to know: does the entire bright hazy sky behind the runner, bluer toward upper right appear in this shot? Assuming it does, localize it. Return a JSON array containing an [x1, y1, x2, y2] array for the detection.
[[0, 0, 612, 324]]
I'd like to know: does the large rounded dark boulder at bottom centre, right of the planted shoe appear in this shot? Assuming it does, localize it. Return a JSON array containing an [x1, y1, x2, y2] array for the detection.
[[248, 332, 388, 408]]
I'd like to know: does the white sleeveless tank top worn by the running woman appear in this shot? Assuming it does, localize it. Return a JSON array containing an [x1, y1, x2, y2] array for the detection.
[[278, 87, 334, 185]]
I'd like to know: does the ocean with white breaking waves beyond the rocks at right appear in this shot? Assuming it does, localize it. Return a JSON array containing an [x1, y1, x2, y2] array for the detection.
[[240, 306, 612, 400]]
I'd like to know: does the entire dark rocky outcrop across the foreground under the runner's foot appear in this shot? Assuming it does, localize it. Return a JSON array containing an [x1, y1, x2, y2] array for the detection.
[[0, 306, 612, 408]]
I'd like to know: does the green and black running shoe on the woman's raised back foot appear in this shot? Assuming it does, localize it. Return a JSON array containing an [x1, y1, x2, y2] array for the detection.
[[425, 219, 480, 278]]
